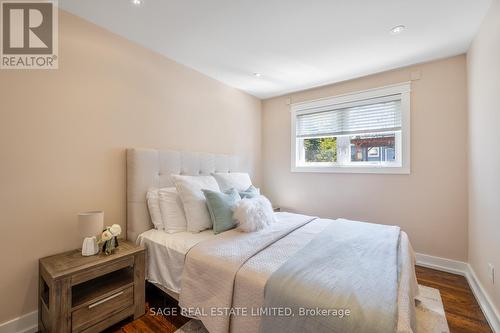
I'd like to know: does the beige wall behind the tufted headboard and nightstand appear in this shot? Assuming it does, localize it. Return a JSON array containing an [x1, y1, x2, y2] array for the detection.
[[0, 13, 261, 323]]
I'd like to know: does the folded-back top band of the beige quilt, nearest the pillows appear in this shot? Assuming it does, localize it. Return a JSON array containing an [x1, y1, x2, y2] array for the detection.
[[179, 213, 315, 333]]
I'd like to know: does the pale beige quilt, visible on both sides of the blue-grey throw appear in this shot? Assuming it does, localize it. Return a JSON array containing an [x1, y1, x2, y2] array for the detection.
[[179, 213, 418, 333]]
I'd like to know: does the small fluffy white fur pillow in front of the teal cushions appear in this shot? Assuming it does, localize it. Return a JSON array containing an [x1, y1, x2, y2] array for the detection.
[[233, 195, 276, 232]]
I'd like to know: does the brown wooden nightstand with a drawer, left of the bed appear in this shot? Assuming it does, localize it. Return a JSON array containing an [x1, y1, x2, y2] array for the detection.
[[38, 240, 145, 333]]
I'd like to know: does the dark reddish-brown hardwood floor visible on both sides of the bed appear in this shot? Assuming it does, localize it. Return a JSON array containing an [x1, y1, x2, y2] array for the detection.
[[106, 266, 492, 333]]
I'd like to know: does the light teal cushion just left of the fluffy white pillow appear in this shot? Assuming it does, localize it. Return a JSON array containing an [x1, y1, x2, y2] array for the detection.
[[202, 188, 241, 234]]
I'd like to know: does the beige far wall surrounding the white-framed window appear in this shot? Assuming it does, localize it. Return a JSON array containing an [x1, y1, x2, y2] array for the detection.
[[262, 55, 467, 260]]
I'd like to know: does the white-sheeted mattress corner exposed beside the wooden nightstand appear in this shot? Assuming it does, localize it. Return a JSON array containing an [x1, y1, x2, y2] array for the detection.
[[137, 229, 215, 294]]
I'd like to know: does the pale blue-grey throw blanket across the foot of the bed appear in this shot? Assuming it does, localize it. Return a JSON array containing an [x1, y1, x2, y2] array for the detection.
[[261, 220, 400, 333]]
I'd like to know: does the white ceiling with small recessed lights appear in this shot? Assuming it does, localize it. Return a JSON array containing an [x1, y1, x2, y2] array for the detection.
[[59, 0, 491, 98]]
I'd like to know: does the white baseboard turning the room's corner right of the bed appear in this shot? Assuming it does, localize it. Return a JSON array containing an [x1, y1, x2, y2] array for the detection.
[[416, 253, 500, 333]]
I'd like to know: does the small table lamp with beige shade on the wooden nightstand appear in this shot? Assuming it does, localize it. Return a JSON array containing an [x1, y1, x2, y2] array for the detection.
[[78, 211, 104, 256]]
